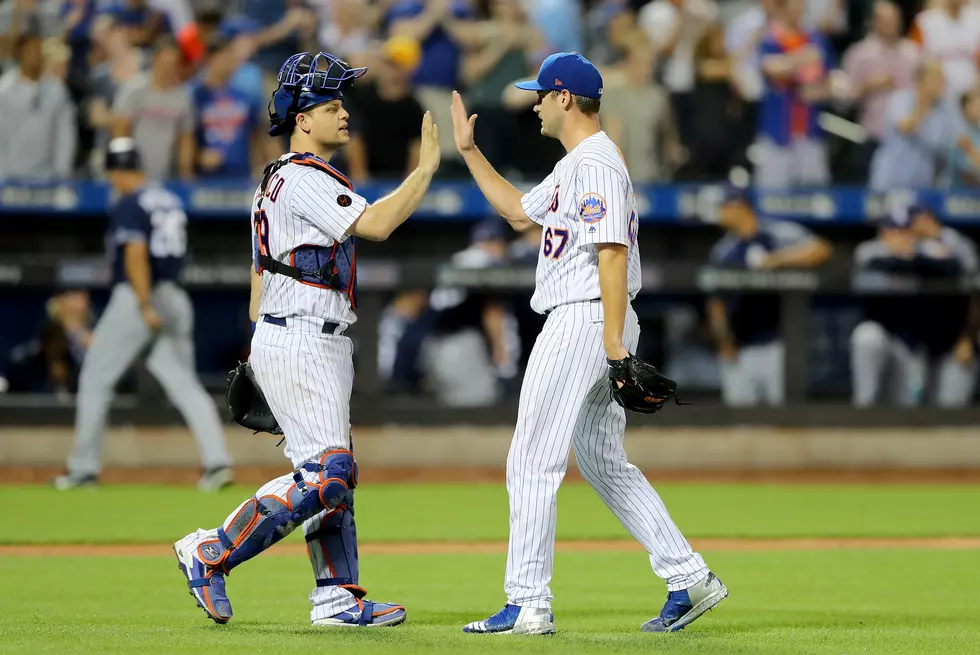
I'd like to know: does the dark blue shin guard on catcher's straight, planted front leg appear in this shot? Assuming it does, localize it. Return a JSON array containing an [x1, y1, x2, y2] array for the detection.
[[303, 503, 367, 598]]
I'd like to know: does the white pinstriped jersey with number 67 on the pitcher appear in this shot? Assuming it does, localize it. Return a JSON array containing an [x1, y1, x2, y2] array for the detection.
[[521, 132, 640, 313]]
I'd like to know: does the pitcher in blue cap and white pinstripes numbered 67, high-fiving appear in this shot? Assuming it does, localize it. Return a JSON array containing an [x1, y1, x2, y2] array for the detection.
[[453, 53, 728, 634]]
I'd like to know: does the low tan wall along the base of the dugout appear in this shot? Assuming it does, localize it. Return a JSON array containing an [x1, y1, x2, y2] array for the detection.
[[0, 426, 980, 472]]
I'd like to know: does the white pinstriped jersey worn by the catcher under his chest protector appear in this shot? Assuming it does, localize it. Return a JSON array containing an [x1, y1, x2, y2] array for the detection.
[[252, 153, 367, 325]]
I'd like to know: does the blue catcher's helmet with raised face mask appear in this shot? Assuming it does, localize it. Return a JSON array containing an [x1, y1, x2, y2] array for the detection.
[[269, 52, 367, 136]]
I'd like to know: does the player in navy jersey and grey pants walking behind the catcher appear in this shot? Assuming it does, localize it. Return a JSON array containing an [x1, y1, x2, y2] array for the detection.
[[53, 139, 231, 491]]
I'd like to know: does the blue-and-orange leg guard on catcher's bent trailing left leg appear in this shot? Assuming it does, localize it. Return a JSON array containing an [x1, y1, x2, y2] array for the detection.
[[198, 450, 357, 573]]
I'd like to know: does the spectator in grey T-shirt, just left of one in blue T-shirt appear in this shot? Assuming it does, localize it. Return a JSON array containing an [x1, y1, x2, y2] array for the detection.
[[112, 37, 194, 180]]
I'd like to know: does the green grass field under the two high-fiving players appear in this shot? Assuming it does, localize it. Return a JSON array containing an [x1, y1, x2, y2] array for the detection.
[[0, 484, 980, 654]]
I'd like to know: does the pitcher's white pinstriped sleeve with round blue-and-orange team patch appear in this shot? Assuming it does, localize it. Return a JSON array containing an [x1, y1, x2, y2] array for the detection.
[[575, 164, 630, 246]]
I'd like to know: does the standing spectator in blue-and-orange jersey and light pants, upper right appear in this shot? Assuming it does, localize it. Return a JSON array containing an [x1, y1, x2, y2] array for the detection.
[[755, 0, 833, 189]]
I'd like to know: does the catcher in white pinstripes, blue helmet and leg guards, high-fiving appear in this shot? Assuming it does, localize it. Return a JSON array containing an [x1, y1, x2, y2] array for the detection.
[[174, 52, 439, 628]]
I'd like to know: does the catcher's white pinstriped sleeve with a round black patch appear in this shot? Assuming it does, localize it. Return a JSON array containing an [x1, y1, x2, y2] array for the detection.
[[290, 171, 367, 241]]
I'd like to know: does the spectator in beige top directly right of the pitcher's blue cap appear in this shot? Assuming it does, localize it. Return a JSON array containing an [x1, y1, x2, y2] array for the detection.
[[596, 6, 686, 183]]
